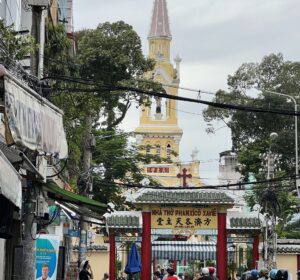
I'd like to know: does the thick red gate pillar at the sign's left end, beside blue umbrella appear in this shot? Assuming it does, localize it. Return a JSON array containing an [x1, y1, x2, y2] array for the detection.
[[141, 209, 151, 280]]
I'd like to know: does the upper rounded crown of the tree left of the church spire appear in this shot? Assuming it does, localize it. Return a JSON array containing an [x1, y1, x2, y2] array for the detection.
[[76, 21, 154, 130]]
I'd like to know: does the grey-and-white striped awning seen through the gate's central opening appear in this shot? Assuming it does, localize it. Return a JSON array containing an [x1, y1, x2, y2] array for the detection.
[[152, 241, 216, 261]]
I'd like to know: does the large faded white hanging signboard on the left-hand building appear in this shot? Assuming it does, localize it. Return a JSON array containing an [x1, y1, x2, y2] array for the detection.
[[4, 76, 68, 158]]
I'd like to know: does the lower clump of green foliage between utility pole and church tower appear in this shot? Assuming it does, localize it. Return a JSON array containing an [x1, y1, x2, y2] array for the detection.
[[93, 130, 162, 205]]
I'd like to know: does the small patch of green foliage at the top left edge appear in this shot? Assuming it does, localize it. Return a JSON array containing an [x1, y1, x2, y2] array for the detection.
[[0, 20, 35, 60]]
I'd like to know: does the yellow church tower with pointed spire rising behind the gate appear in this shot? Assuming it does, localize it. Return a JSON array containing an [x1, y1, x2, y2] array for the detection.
[[135, 0, 203, 187]]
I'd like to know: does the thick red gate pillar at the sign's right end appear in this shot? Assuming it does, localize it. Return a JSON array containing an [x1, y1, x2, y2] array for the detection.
[[217, 208, 227, 280]]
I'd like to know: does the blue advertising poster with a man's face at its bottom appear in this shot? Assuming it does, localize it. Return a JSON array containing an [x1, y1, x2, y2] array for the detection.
[[36, 234, 60, 280]]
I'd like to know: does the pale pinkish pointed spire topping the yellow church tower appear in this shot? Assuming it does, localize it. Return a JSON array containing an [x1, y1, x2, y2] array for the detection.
[[148, 0, 172, 39]]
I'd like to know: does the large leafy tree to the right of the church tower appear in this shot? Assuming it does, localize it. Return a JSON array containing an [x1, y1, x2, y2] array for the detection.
[[204, 54, 300, 229]]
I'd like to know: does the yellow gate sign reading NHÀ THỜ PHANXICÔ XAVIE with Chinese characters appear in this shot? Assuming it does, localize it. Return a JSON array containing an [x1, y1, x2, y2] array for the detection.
[[151, 207, 218, 229]]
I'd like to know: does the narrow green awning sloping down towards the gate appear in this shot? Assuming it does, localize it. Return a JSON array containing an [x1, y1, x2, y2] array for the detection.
[[44, 181, 107, 215]]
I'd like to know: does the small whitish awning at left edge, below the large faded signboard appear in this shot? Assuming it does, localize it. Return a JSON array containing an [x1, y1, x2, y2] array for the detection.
[[0, 149, 22, 209]]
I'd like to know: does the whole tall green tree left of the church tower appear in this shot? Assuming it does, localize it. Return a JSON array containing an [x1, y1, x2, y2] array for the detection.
[[45, 22, 162, 205]]
